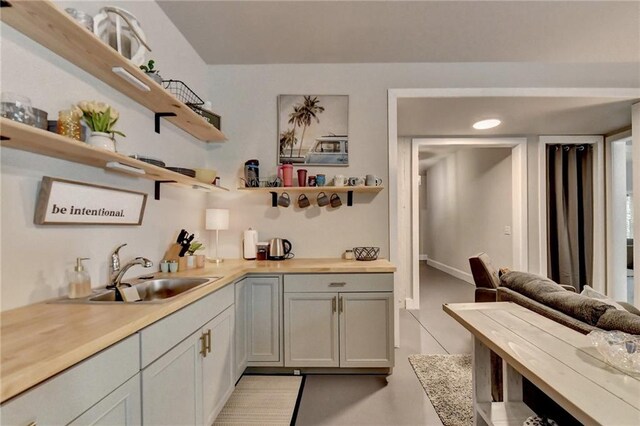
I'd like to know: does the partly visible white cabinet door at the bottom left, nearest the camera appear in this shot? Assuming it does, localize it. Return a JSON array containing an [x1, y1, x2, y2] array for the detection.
[[69, 374, 142, 426]]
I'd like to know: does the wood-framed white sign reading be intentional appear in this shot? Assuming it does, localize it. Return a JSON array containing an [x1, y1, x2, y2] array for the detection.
[[34, 176, 147, 225]]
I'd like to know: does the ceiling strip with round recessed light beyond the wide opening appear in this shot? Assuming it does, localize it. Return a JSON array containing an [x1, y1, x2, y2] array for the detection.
[[398, 97, 638, 136]]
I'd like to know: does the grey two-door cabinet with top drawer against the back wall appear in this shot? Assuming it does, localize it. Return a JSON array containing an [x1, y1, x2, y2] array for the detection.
[[284, 274, 394, 368]]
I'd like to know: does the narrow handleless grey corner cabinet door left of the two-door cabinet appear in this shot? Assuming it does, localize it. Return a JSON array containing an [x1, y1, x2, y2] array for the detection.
[[245, 277, 282, 366]]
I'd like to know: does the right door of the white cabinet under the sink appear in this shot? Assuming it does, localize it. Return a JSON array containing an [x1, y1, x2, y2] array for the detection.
[[202, 306, 236, 425]]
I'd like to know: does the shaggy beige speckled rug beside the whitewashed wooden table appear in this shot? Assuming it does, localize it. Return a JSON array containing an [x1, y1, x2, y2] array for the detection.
[[409, 354, 473, 426]]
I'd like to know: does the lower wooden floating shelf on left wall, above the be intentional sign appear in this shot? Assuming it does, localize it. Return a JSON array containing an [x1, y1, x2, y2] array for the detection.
[[0, 117, 228, 199]]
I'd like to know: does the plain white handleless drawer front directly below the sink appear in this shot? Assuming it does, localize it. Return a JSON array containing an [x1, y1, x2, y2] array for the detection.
[[140, 285, 234, 368]]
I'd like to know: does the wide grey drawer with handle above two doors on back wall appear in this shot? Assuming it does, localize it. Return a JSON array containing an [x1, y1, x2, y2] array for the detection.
[[284, 273, 393, 293]]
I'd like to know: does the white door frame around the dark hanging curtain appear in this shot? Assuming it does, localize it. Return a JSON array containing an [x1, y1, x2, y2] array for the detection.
[[538, 135, 606, 293]]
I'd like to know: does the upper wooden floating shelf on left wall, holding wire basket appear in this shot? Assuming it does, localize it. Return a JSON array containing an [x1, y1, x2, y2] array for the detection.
[[0, 0, 226, 142]]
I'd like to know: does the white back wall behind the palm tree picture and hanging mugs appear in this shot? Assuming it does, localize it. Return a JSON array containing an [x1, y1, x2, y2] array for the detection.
[[209, 63, 640, 257]]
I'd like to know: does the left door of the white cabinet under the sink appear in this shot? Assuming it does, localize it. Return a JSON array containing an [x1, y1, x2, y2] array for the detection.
[[142, 330, 202, 425]]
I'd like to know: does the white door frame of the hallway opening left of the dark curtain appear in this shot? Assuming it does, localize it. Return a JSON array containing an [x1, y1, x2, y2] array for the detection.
[[405, 137, 528, 309]]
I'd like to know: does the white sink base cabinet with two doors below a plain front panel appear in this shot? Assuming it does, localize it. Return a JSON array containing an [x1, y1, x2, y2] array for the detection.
[[141, 286, 235, 425]]
